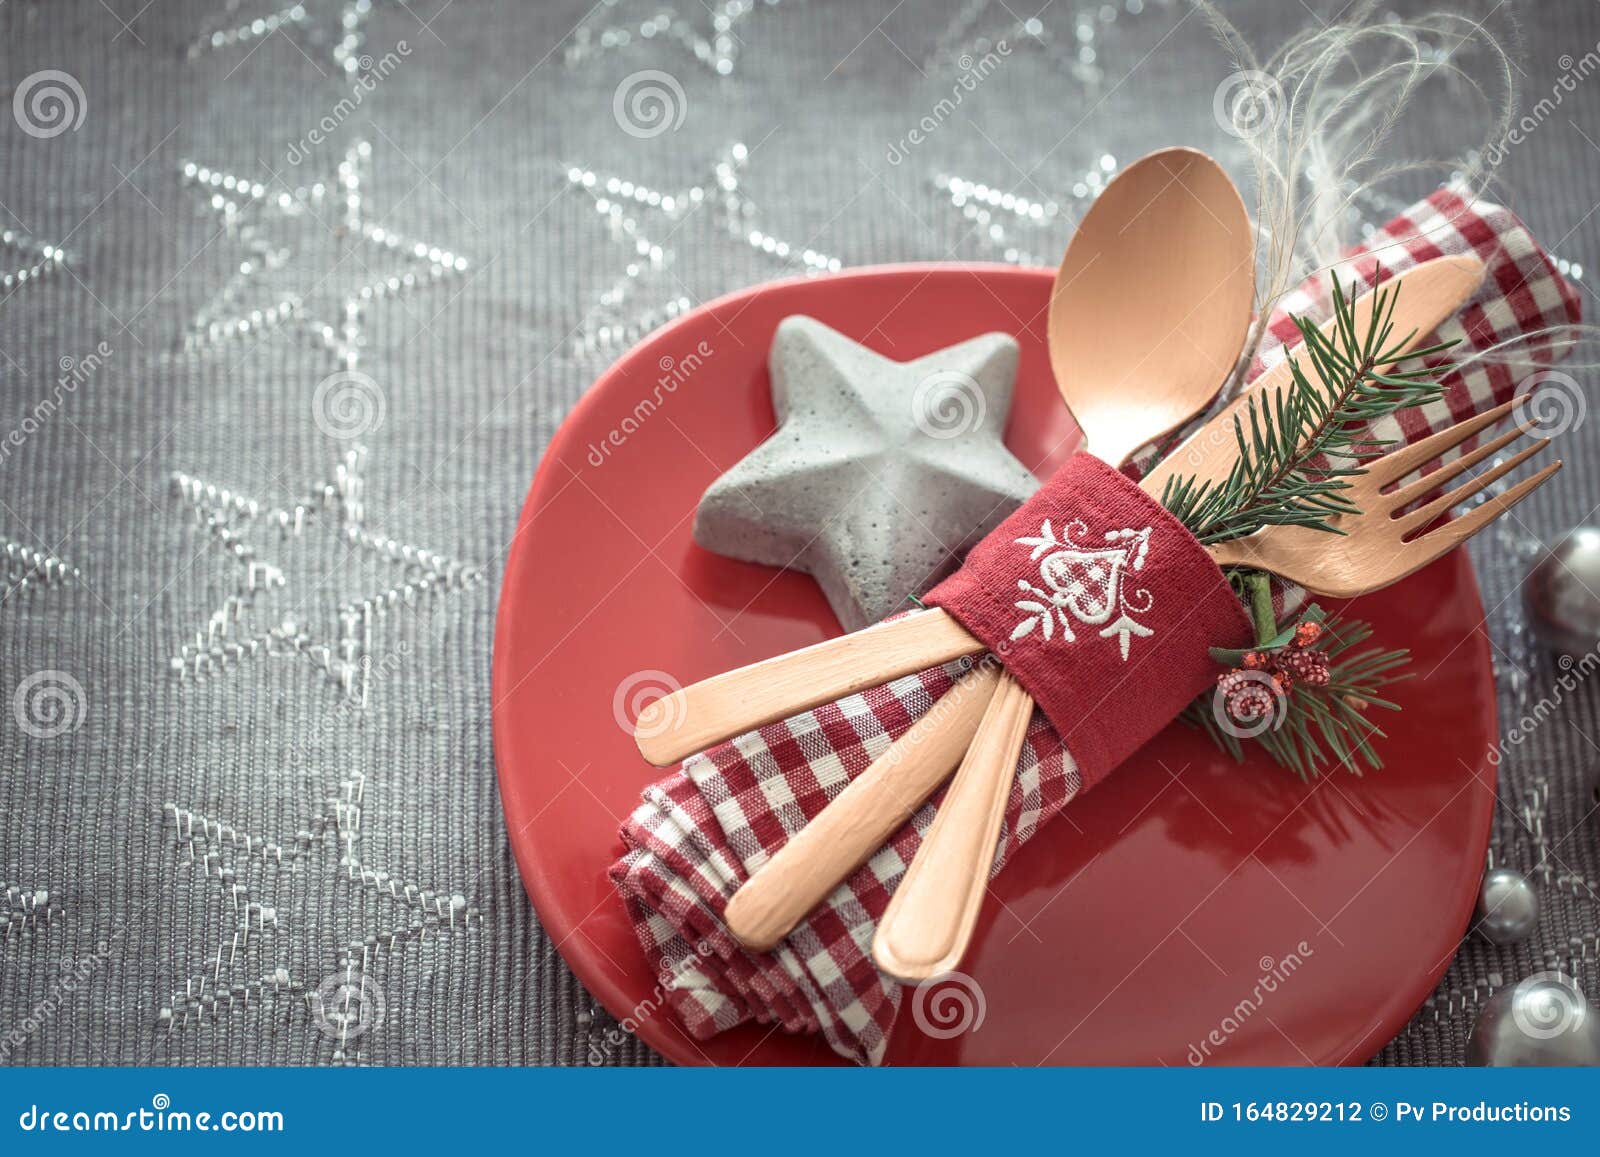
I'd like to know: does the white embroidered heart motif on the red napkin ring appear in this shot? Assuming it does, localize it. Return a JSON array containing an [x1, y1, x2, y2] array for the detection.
[[1011, 518, 1155, 663]]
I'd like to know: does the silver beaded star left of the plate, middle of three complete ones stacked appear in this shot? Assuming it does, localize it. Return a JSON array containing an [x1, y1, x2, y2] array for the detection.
[[168, 446, 483, 707]]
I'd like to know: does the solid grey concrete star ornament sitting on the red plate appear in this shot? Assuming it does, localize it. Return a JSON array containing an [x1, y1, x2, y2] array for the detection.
[[694, 315, 1038, 631]]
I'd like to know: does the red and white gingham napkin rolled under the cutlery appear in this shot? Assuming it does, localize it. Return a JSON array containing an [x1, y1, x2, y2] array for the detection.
[[611, 189, 1579, 1064]]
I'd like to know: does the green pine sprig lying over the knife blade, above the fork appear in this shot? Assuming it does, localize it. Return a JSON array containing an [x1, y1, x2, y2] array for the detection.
[[1162, 282, 1456, 546]]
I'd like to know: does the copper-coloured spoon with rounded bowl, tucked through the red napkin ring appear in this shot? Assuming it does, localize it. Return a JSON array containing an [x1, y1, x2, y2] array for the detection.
[[872, 149, 1256, 981]]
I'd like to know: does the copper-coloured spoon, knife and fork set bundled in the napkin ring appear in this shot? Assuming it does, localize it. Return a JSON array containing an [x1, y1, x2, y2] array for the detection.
[[635, 149, 1560, 981]]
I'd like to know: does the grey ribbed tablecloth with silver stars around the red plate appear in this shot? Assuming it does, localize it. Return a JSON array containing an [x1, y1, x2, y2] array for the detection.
[[0, 0, 1600, 1064]]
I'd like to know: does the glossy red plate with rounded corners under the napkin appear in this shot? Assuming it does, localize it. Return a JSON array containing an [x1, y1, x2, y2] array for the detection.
[[494, 266, 1496, 1064]]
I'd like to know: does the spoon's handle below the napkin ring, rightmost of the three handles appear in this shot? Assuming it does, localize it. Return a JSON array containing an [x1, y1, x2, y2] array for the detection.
[[872, 674, 1034, 981]]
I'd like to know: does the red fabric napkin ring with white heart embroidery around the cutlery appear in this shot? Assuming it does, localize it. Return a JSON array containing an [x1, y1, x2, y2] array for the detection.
[[925, 454, 1254, 787]]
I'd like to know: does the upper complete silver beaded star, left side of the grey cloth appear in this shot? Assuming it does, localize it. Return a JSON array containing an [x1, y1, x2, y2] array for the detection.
[[181, 141, 469, 370]]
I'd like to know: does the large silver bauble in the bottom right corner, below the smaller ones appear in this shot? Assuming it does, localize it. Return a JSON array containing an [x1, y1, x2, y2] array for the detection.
[[1467, 973, 1600, 1067]]
